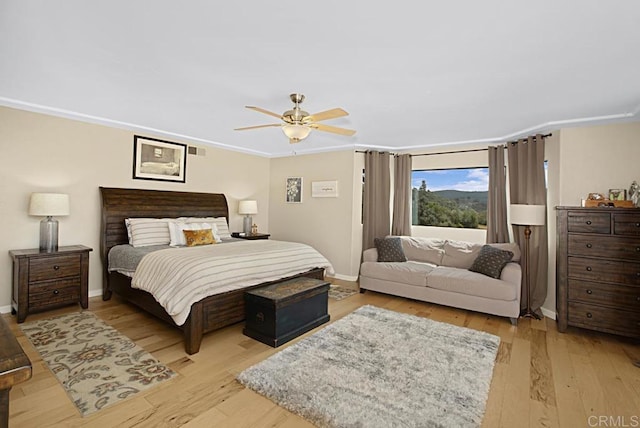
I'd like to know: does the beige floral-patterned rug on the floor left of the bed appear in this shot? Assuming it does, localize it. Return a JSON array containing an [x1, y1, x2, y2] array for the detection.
[[21, 311, 175, 416]]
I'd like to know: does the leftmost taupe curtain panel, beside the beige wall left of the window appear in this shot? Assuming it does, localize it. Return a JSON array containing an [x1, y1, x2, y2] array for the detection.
[[362, 151, 391, 251]]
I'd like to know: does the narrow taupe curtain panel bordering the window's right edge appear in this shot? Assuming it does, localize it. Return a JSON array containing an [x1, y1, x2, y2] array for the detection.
[[487, 146, 509, 244]]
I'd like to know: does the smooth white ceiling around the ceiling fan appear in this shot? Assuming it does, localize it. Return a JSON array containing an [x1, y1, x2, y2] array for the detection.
[[0, 0, 640, 156]]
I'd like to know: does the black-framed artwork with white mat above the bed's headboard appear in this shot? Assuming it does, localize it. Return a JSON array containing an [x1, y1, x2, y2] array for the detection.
[[133, 135, 187, 183]]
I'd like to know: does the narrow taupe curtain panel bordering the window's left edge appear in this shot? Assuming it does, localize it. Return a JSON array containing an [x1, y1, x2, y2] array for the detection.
[[391, 154, 411, 236]]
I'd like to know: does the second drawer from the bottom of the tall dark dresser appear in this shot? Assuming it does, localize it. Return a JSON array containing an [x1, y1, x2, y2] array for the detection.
[[568, 279, 640, 312]]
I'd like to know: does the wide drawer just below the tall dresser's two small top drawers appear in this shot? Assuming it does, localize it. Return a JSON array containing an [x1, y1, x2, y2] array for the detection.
[[567, 234, 640, 262]]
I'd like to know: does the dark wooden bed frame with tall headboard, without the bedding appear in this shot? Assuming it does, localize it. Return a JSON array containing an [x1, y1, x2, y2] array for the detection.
[[100, 187, 324, 354]]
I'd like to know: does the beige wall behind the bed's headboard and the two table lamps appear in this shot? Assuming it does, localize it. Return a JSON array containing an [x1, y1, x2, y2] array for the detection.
[[0, 107, 270, 312]]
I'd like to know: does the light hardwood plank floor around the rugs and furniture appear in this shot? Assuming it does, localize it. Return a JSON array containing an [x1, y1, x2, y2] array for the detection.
[[3, 282, 640, 428]]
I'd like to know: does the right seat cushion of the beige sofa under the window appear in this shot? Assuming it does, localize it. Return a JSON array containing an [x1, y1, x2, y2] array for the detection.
[[427, 266, 517, 301]]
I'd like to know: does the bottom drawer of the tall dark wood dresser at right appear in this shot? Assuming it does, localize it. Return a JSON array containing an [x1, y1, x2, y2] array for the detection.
[[568, 302, 640, 337]]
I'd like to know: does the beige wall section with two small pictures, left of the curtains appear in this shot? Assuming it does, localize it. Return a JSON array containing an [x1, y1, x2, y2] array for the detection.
[[269, 151, 362, 280]]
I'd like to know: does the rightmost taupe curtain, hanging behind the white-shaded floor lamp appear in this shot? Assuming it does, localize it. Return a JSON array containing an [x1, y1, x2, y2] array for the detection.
[[507, 135, 548, 315]]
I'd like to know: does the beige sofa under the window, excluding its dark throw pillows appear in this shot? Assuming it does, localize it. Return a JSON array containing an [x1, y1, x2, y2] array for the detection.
[[360, 236, 522, 325]]
